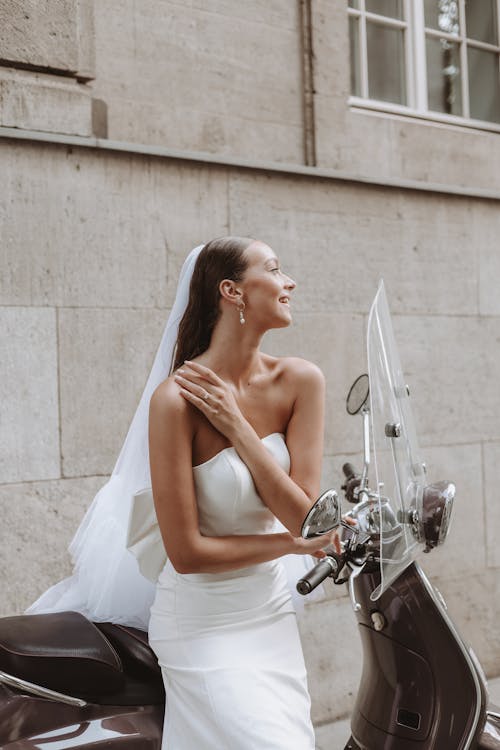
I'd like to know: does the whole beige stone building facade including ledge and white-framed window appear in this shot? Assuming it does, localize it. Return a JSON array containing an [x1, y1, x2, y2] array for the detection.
[[0, 0, 500, 736]]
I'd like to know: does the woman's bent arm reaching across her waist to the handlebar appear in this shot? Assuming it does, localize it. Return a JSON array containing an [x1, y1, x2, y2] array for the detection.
[[149, 379, 330, 573]]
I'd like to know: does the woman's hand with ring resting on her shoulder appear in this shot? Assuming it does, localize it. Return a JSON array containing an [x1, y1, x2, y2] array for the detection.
[[174, 360, 245, 440]]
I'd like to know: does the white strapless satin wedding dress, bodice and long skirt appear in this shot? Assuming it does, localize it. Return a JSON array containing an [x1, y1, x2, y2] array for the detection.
[[149, 433, 315, 750]]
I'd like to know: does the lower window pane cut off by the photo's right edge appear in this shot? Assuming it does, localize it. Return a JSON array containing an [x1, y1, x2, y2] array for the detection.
[[467, 47, 500, 122]]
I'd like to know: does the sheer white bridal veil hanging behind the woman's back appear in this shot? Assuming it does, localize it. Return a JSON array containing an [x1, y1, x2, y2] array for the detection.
[[25, 245, 324, 630]]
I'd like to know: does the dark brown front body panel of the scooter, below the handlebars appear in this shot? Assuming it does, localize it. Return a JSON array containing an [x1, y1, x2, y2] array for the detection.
[[346, 563, 500, 750]]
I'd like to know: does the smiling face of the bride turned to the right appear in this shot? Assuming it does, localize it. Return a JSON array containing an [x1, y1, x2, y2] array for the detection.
[[238, 240, 296, 328]]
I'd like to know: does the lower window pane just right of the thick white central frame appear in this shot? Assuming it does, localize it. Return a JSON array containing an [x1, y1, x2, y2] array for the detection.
[[426, 36, 462, 115]]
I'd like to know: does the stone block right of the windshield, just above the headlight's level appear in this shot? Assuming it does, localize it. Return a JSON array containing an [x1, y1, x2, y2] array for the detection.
[[393, 316, 500, 445]]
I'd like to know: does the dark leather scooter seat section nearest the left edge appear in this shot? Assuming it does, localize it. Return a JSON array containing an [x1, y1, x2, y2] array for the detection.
[[0, 612, 125, 696]]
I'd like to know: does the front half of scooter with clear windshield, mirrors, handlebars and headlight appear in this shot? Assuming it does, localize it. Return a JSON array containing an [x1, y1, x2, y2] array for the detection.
[[297, 284, 500, 750]]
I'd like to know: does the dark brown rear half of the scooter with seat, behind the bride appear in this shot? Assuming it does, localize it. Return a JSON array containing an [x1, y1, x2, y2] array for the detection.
[[0, 612, 165, 750]]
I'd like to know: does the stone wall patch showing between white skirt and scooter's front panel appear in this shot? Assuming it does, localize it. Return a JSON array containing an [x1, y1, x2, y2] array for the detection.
[[299, 596, 362, 724]]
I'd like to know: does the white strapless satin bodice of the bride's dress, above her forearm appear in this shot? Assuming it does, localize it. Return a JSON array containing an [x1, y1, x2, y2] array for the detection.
[[193, 432, 290, 536]]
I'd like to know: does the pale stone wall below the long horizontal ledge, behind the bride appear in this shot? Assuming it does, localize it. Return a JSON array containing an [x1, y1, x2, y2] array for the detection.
[[0, 141, 500, 722]]
